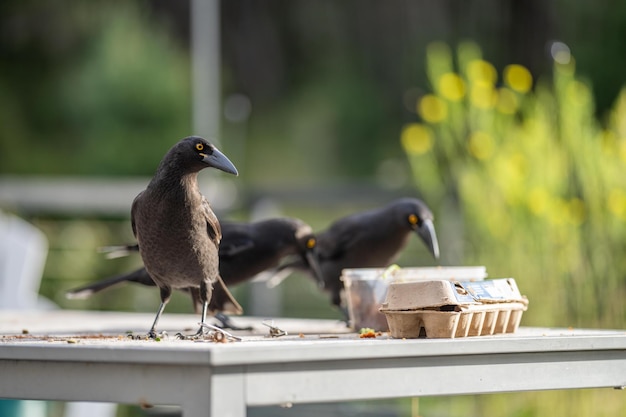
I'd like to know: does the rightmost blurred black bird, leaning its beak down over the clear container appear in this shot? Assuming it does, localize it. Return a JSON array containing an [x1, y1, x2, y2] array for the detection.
[[272, 198, 439, 314]]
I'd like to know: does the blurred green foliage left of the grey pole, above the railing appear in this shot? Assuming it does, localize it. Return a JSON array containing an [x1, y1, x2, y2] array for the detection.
[[0, 1, 191, 175]]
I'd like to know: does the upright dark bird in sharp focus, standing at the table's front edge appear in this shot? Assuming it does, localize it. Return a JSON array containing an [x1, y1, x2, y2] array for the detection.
[[131, 136, 241, 338]]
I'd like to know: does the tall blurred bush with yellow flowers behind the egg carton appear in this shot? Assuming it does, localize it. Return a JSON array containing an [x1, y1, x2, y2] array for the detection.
[[401, 43, 626, 416]]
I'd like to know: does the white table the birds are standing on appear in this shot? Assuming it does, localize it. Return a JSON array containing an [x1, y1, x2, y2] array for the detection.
[[0, 311, 626, 417]]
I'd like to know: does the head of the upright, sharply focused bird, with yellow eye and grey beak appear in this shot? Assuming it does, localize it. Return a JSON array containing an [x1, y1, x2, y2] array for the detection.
[[172, 136, 239, 175]]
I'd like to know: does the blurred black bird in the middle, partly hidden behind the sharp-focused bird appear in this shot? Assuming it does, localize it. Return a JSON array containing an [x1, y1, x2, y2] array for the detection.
[[67, 218, 321, 328]]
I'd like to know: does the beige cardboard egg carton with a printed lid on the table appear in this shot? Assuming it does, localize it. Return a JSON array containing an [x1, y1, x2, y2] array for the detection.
[[380, 278, 528, 339]]
